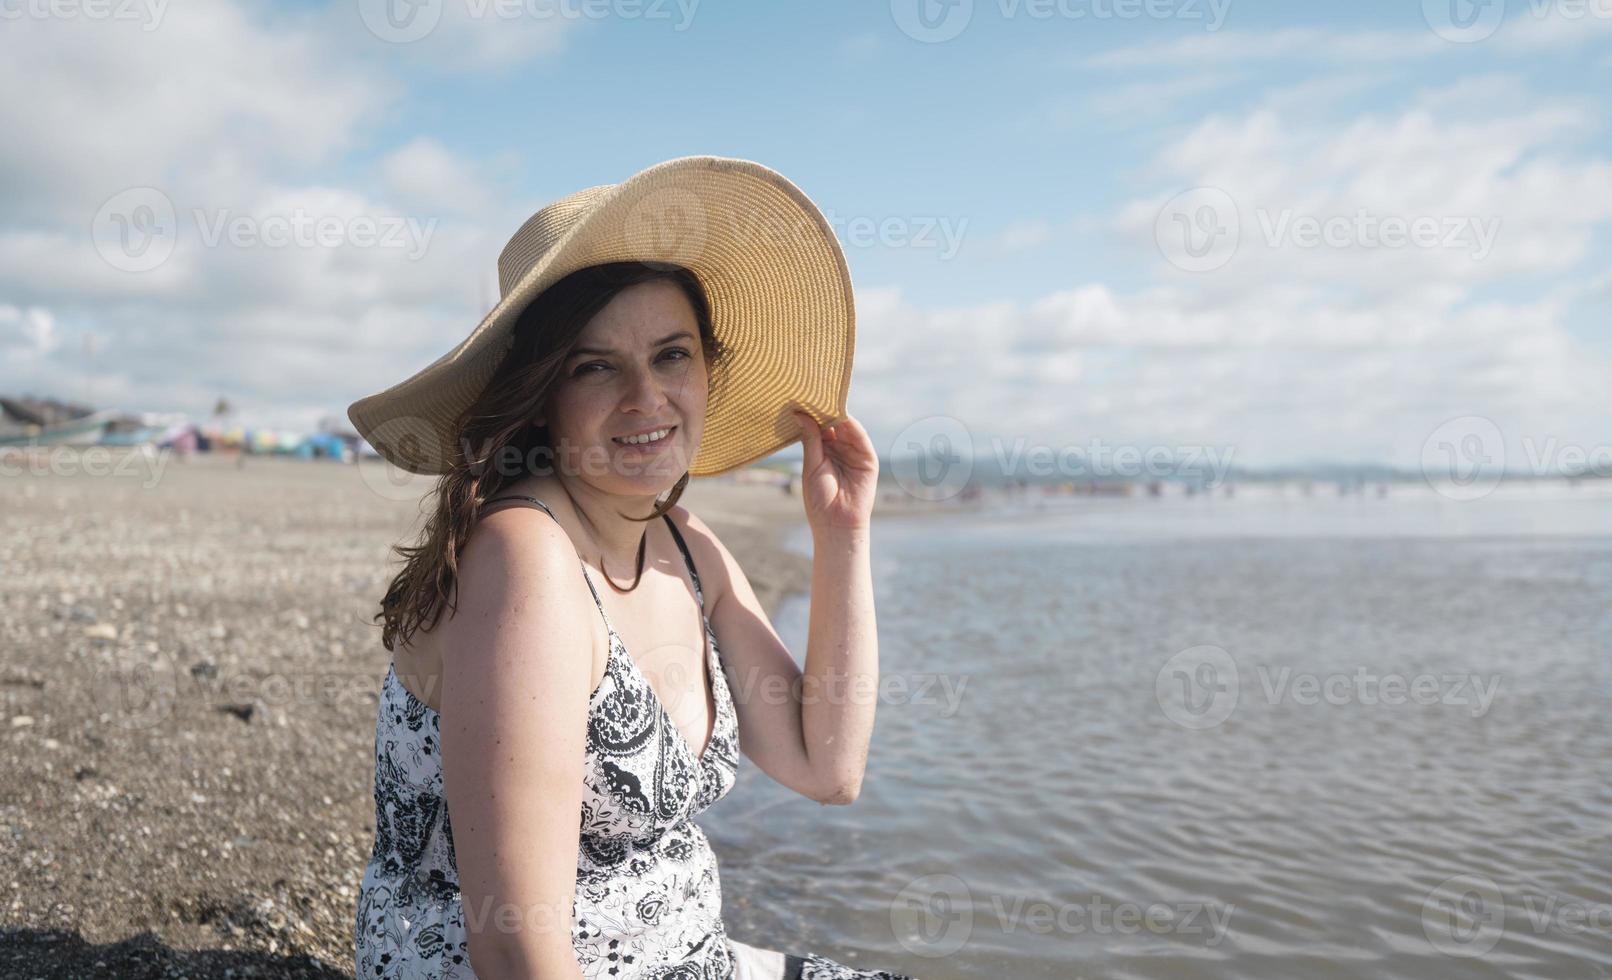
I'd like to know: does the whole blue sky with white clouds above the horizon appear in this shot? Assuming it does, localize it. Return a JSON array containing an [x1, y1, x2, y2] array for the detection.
[[0, 0, 1612, 466]]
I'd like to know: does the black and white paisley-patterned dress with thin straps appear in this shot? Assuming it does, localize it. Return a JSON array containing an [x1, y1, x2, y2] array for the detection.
[[356, 496, 911, 980]]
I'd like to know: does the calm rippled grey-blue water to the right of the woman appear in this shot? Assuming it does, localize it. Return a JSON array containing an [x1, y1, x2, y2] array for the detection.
[[703, 488, 1612, 980]]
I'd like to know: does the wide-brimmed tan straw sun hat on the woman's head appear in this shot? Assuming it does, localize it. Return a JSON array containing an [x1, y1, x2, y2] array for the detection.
[[347, 156, 856, 477]]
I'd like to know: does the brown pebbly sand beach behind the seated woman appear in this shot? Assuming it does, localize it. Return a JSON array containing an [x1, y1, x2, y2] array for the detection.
[[0, 455, 809, 977]]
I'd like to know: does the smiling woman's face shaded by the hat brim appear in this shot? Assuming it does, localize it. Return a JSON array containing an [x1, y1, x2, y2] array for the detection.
[[546, 280, 708, 496]]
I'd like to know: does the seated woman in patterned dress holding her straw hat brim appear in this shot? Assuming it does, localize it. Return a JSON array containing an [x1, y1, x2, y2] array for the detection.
[[348, 158, 908, 980]]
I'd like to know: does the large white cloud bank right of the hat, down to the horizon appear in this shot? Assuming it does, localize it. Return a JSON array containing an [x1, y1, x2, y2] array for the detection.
[[854, 91, 1612, 466]]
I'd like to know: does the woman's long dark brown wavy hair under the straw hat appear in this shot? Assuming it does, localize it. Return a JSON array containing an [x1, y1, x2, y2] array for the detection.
[[372, 261, 732, 650]]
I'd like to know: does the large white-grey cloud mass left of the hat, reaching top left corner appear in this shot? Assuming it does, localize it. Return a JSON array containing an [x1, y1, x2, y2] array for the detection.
[[0, 3, 553, 426]]
